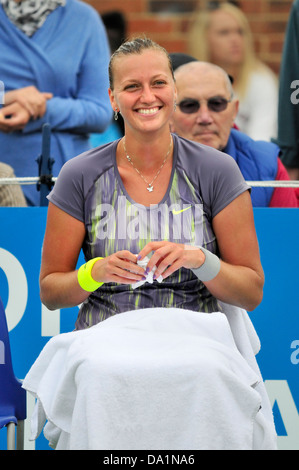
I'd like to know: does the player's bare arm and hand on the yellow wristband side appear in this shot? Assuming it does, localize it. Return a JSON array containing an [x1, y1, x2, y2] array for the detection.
[[40, 203, 148, 310]]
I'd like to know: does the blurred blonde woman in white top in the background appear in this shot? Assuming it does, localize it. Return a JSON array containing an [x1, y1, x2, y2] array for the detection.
[[188, 2, 278, 140]]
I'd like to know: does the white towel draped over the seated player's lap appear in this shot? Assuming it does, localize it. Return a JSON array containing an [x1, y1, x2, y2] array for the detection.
[[23, 308, 276, 450]]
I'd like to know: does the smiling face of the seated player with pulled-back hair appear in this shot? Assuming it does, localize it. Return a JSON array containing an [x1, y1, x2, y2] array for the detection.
[[109, 49, 176, 132]]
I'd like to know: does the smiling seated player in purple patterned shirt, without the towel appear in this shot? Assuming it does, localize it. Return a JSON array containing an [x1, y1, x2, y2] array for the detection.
[[40, 38, 264, 329]]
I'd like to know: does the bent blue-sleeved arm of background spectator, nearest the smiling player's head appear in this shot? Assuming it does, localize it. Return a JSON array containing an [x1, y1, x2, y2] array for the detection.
[[24, 18, 112, 134]]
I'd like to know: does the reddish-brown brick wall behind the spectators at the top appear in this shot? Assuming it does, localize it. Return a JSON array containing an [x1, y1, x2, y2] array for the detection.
[[85, 0, 293, 73]]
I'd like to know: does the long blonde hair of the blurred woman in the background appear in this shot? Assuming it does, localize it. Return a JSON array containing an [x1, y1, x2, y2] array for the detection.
[[188, 2, 274, 98]]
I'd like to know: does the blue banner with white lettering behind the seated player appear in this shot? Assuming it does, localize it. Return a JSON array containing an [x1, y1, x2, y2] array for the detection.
[[0, 207, 299, 450]]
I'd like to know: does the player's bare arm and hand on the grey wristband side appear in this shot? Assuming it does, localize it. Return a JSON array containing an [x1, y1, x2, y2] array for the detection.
[[140, 192, 264, 310]]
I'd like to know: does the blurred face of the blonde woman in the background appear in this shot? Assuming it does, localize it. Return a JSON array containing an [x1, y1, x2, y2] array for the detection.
[[208, 10, 245, 68]]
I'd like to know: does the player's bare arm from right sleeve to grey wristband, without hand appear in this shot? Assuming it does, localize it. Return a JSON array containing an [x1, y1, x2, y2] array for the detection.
[[205, 192, 264, 311]]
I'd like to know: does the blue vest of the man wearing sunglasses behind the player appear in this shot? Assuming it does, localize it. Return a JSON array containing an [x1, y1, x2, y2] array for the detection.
[[223, 129, 280, 207]]
